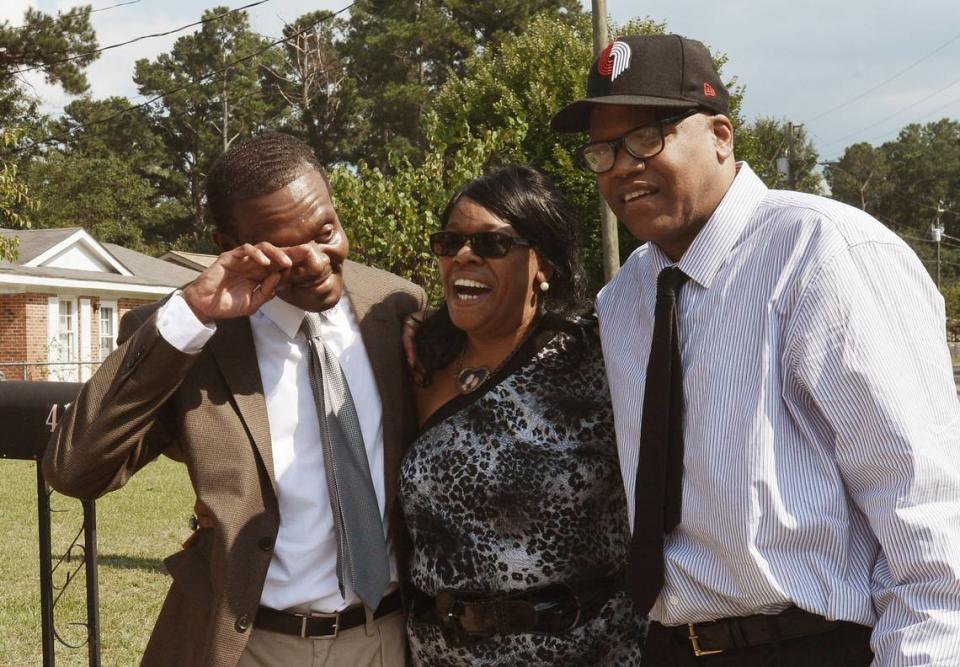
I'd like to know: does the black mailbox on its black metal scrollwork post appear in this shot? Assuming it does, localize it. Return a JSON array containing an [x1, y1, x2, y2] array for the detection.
[[0, 382, 100, 667]]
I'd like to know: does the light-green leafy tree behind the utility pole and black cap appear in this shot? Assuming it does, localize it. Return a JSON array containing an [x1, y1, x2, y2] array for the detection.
[[430, 15, 742, 288]]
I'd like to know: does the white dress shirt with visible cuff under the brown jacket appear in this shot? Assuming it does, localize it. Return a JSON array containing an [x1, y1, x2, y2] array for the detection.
[[157, 294, 397, 612]]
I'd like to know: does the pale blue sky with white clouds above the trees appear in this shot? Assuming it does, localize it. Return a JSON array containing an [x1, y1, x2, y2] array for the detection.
[[7, 0, 960, 161]]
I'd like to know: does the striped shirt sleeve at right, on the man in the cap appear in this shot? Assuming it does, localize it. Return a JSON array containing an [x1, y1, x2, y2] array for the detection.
[[795, 243, 960, 667]]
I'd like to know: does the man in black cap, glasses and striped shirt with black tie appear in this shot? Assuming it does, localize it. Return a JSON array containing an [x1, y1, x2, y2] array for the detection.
[[553, 35, 960, 667]]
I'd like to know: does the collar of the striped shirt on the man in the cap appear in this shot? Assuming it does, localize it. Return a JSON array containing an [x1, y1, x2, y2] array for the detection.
[[672, 162, 767, 289]]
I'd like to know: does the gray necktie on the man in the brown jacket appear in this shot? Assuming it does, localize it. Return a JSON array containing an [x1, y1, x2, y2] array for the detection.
[[300, 313, 390, 609]]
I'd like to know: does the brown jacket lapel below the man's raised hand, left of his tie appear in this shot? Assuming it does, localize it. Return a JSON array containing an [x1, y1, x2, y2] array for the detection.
[[208, 317, 277, 494]]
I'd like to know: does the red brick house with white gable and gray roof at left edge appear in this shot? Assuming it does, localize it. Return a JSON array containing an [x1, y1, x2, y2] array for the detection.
[[0, 228, 197, 381]]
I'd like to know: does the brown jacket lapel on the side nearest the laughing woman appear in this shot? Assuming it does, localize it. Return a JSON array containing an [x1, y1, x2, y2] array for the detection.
[[343, 262, 405, 515]]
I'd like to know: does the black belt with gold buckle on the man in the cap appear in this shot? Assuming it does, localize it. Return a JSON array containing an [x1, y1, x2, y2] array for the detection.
[[654, 607, 868, 658]]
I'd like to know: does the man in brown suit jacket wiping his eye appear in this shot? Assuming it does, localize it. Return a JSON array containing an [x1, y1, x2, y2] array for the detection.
[[43, 133, 425, 667]]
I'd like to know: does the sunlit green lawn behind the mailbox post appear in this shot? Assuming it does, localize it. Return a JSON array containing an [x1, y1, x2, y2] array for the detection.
[[0, 458, 193, 667]]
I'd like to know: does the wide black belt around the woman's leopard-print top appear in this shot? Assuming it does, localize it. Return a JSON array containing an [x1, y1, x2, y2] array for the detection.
[[409, 574, 624, 645]]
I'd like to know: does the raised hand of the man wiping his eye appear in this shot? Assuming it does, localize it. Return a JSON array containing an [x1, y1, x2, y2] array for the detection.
[[183, 242, 318, 324]]
